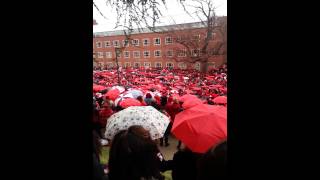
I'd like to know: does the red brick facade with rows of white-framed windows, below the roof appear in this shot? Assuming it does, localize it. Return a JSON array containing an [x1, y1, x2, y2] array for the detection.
[[93, 18, 226, 68]]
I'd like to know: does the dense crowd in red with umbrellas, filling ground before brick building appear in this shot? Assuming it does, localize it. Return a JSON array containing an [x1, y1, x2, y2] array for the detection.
[[92, 65, 227, 180]]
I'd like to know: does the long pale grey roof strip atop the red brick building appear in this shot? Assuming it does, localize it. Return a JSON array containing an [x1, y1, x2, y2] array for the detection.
[[93, 16, 226, 37]]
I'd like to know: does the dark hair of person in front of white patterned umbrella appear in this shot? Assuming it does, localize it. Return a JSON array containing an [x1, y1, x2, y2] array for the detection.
[[109, 126, 164, 180]]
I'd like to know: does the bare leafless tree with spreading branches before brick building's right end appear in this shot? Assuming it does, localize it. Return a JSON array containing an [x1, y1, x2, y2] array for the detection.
[[167, 0, 227, 72]]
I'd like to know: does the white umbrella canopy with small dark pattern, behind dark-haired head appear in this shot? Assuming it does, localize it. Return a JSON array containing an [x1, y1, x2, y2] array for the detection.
[[105, 106, 170, 139]]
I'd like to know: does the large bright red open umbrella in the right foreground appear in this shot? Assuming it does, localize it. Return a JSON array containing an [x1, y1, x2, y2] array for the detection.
[[171, 104, 227, 153]]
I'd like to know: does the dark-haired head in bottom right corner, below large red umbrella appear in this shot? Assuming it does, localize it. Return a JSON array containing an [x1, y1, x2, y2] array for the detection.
[[197, 141, 227, 180]]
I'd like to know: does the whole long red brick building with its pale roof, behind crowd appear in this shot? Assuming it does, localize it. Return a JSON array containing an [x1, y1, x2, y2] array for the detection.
[[93, 17, 227, 69]]
